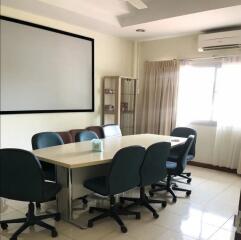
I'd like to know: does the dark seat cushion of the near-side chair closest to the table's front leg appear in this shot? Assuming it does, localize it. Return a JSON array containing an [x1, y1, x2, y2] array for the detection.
[[84, 176, 108, 196]]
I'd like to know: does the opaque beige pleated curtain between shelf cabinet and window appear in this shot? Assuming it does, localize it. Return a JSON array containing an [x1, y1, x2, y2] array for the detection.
[[137, 60, 179, 135]]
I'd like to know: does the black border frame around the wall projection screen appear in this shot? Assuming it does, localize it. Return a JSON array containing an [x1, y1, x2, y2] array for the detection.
[[0, 15, 95, 115]]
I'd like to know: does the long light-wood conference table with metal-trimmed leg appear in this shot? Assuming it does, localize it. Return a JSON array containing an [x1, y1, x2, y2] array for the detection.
[[33, 134, 186, 228]]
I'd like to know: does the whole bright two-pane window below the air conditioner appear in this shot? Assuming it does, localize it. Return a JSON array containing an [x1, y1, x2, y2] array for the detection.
[[177, 62, 241, 126]]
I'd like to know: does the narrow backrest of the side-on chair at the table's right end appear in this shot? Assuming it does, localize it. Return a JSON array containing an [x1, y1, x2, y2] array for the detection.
[[174, 135, 195, 175]]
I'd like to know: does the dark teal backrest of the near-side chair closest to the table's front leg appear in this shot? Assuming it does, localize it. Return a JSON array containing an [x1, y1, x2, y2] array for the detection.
[[107, 146, 145, 195]]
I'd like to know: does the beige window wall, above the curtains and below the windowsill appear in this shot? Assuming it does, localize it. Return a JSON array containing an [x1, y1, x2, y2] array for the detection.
[[138, 35, 241, 164]]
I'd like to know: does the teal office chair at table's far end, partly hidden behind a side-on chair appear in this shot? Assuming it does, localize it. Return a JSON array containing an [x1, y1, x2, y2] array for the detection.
[[169, 127, 197, 183]]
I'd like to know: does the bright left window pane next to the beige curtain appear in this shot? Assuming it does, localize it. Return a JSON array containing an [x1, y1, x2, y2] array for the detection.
[[177, 62, 216, 125]]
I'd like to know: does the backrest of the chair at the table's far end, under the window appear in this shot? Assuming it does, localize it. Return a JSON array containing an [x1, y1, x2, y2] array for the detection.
[[171, 127, 197, 157]]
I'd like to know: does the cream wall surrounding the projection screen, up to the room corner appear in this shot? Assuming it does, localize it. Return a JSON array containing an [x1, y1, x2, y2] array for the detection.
[[0, 6, 134, 149]]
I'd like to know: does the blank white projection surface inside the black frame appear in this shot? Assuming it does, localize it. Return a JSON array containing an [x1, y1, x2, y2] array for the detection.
[[1, 17, 93, 113]]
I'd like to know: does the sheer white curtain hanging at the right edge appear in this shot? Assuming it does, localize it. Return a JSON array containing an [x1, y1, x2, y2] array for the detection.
[[213, 57, 241, 174]]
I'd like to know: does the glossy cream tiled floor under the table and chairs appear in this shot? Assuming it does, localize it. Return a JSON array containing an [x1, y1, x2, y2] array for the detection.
[[0, 167, 241, 240]]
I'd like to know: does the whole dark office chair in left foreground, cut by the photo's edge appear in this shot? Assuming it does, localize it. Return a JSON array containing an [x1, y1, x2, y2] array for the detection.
[[0, 148, 61, 240]]
